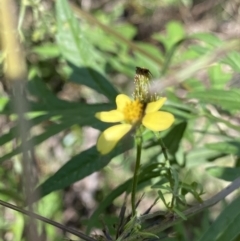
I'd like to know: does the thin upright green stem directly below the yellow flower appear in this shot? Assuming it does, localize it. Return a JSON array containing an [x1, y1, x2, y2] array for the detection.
[[132, 137, 142, 217]]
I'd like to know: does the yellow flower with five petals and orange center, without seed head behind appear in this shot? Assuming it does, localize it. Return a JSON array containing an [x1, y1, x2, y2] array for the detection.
[[95, 94, 174, 155]]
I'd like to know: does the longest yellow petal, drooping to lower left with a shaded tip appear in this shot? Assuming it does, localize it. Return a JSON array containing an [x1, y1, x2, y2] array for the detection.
[[97, 124, 132, 155]]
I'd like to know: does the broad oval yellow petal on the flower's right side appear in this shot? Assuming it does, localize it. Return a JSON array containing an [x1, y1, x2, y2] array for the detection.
[[142, 111, 174, 131]]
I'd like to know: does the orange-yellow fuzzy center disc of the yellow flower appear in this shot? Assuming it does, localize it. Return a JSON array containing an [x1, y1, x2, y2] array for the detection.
[[123, 100, 143, 124]]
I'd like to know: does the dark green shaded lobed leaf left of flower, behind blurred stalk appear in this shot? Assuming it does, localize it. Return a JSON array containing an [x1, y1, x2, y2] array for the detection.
[[0, 78, 114, 162]]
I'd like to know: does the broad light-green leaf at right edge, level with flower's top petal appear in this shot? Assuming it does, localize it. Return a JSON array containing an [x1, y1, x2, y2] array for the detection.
[[187, 89, 240, 110]]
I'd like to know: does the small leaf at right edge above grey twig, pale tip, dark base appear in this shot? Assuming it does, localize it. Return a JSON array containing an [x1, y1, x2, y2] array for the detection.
[[206, 167, 240, 182]]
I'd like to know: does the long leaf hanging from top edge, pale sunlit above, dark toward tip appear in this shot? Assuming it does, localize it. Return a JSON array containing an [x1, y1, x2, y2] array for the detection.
[[56, 0, 117, 100]]
